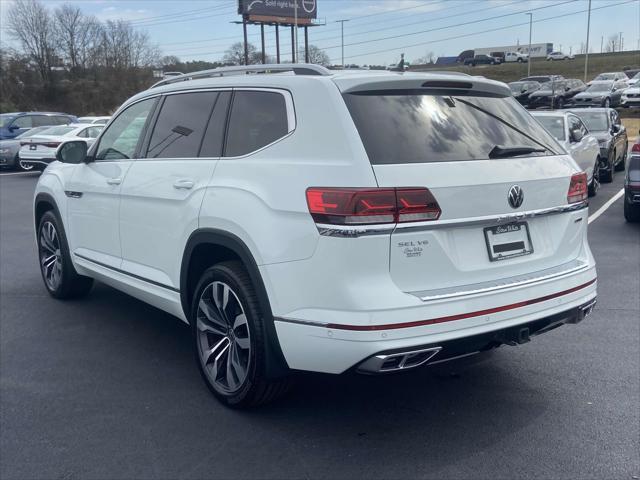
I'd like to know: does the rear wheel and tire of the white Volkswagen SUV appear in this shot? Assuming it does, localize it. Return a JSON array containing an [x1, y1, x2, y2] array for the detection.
[[189, 261, 291, 408]]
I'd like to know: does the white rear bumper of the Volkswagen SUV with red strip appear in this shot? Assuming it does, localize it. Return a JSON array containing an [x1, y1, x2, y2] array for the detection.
[[275, 266, 597, 373]]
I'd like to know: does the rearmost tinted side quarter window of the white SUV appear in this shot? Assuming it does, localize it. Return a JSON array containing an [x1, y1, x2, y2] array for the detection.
[[225, 92, 289, 157]]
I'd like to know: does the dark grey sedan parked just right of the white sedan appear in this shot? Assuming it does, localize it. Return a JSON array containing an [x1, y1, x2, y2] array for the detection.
[[571, 108, 629, 182]]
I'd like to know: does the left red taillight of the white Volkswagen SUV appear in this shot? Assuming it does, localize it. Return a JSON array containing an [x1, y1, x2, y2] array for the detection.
[[307, 187, 441, 225]]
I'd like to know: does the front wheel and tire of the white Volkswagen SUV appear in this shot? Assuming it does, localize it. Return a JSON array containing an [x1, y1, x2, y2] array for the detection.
[[37, 210, 93, 300]]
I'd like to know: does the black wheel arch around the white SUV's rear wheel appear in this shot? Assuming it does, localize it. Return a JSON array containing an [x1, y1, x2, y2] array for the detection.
[[180, 228, 289, 378]]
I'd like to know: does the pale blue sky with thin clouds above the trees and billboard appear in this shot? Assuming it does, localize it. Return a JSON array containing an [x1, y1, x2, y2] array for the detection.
[[0, 0, 640, 64]]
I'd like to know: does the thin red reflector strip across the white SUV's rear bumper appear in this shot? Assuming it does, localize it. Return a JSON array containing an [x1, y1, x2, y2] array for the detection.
[[326, 278, 597, 332]]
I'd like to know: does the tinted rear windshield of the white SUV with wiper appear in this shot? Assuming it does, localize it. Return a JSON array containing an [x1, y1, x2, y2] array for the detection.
[[344, 91, 562, 165]]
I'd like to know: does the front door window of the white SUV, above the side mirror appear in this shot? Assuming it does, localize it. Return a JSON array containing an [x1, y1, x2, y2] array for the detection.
[[96, 98, 156, 160]]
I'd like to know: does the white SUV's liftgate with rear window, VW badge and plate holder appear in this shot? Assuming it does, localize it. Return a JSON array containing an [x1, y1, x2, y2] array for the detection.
[[344, 90, 583, 292]]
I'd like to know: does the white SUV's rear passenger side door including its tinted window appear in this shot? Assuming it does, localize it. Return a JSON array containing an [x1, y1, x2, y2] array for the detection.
[[120, 90, 231, 289]]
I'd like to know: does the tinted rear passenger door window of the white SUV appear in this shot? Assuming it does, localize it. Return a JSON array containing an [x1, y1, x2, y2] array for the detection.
[[147, 92, 218, 158]]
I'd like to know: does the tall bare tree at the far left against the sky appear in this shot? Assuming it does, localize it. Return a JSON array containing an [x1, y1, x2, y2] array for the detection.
[[8, 0, 55, 92]]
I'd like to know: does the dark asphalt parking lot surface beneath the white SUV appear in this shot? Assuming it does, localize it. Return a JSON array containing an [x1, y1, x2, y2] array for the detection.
[[0, 174, 640, 479]]
